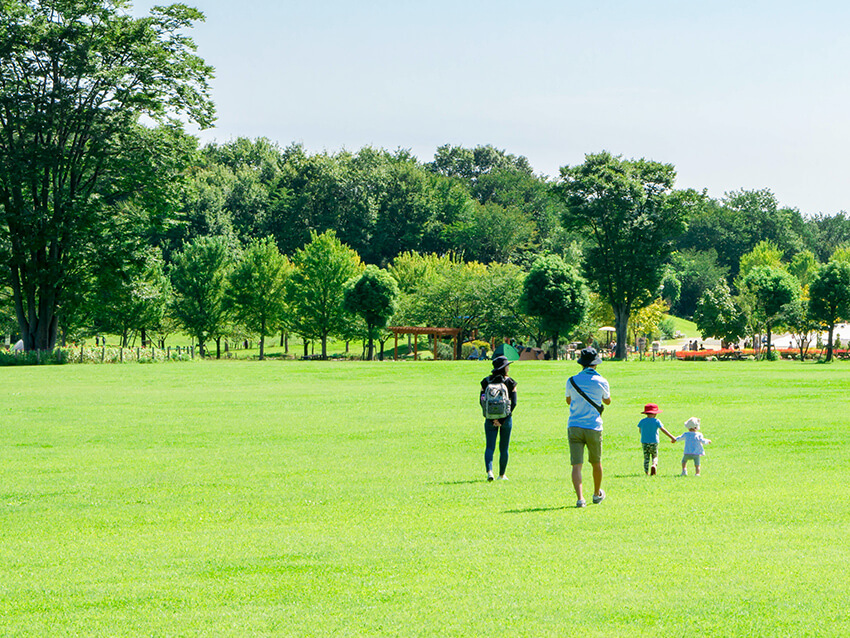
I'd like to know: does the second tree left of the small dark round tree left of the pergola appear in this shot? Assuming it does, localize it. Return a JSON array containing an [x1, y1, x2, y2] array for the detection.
[[226, 237, 292, 361]]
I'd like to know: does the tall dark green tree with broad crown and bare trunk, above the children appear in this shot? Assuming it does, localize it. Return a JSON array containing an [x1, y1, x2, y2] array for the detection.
[[558, 152, 689, 359]]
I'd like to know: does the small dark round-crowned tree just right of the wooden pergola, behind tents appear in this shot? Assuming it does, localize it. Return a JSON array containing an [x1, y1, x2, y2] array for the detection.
[[519, 255, 589, 359]]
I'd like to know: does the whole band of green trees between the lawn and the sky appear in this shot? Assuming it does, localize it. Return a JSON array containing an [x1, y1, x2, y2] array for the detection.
[[0, 0, 850, 358]]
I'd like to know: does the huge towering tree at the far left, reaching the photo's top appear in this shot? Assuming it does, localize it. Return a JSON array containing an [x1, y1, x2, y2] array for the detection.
[[0, 0, 213, 349]]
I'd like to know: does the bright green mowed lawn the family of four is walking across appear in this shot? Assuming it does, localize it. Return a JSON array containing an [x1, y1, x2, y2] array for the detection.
[[0, 361, 850, 637]]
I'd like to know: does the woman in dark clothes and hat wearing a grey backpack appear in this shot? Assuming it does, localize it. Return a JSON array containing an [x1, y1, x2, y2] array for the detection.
[[479, 356, 517, 481]]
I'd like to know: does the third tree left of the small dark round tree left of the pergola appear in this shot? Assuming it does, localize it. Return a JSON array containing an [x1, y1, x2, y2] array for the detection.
[[171, 237, 232, 356]]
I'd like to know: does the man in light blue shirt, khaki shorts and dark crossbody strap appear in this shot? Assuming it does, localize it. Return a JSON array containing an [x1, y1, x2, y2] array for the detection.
[[566, 348, 611, 507]]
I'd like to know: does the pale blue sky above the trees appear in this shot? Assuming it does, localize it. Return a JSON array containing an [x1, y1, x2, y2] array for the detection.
[[134, 0, 850, 214]]
